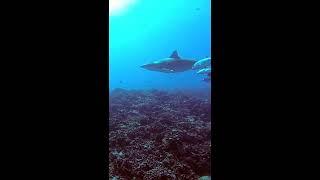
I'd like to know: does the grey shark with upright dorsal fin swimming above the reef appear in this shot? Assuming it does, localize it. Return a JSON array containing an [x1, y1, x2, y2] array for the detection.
[[140, 50, 196, 73]]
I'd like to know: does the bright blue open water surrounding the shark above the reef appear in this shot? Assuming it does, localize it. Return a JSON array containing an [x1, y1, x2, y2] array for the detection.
[[109, 0, 211, 91]]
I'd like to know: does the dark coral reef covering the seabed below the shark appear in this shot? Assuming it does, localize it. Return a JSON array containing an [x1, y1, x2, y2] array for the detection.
[[109, 89, 211, 180]]
